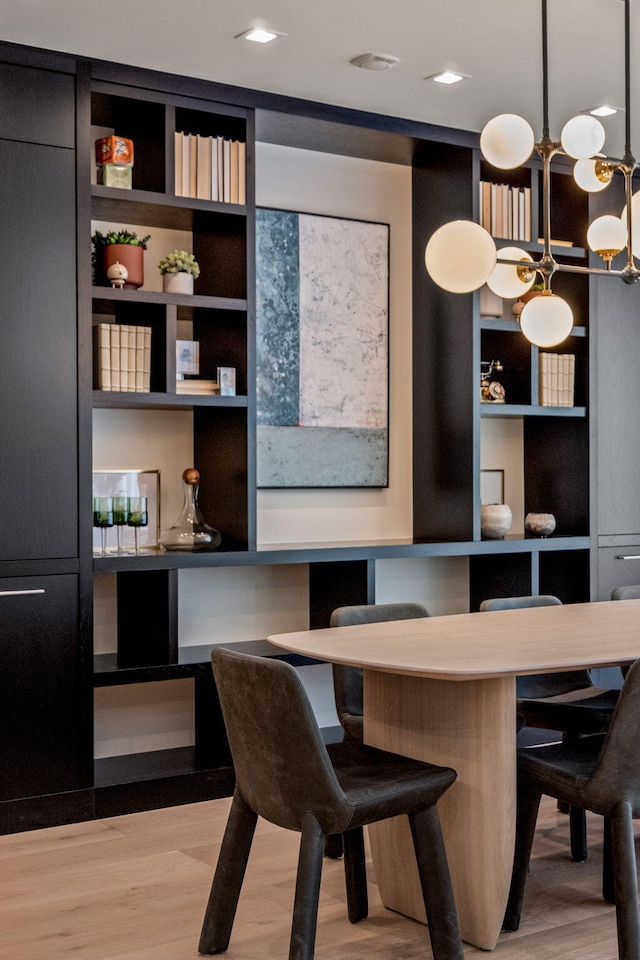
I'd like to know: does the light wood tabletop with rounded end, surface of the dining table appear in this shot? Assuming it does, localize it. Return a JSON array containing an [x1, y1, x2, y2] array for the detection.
[[268, 600, 640, 680]]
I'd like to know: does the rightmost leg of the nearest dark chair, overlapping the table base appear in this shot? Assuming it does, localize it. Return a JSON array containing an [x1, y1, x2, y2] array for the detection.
[[409, 804, 463, 960]]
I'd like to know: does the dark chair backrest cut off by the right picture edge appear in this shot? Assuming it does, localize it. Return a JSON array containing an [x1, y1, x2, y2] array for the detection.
[[584, 660, 640, 818]]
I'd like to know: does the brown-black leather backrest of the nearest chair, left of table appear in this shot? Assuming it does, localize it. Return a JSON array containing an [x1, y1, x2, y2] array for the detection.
[[211, 647, 347, 830]]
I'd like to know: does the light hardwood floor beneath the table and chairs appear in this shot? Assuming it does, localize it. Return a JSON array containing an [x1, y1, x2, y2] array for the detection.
[[0, 800, 632, 960]]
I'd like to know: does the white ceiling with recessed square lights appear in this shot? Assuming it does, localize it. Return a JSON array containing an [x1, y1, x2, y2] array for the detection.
[[0, 0, 640, 156]]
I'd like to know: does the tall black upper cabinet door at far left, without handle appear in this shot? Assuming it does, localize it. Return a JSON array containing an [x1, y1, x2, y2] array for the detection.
[[0, 140, 78, 560]]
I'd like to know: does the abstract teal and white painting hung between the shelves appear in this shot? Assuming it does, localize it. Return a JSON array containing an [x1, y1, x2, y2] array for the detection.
[[256, 209, 389, 487]]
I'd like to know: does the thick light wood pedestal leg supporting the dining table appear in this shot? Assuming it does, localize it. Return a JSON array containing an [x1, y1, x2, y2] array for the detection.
[[364, 670, 516, 950]]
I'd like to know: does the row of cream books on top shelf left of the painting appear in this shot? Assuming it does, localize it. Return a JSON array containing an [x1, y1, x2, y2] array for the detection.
[[175, 132, 247, 203]]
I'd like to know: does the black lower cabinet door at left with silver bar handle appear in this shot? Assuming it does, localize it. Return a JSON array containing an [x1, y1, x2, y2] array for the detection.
[[0, 574, 90, 800]]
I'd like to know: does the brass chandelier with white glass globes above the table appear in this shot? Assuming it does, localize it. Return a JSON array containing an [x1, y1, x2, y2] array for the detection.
[[425, 0, 640, 347]]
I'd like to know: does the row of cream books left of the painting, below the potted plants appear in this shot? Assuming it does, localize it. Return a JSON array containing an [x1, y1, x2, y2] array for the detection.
[[93, 323, 151, 393]]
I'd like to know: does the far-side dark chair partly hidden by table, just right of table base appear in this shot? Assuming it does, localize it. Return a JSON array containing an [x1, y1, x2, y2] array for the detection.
[[480, 594, 619, 861]]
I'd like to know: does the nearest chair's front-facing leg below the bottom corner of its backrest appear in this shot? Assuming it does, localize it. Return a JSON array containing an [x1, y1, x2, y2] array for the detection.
[[289, 812, 325, 960]]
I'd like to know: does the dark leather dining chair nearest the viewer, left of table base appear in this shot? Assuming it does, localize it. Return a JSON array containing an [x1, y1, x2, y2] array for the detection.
[[199, 648, 463, 960]]
